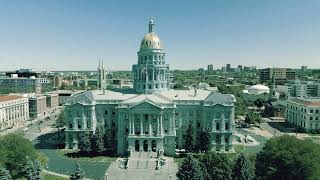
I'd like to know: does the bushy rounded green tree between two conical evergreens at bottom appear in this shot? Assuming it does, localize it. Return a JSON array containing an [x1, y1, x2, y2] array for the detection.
[[200, 152, 232, 180]]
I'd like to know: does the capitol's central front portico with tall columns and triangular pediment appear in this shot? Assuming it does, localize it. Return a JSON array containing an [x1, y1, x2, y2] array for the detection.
[[118, 95, 176, 156]]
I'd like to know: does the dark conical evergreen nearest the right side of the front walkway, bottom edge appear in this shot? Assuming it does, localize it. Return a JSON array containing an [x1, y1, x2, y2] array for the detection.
[[177, 154, 203, 180]]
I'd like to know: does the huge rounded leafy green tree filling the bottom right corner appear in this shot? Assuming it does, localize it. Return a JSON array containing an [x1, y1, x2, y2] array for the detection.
[[255, 135, 320, 180]]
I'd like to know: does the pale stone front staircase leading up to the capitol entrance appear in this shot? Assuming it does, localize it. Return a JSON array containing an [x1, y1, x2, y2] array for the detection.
[[127, 151, 157, 170]]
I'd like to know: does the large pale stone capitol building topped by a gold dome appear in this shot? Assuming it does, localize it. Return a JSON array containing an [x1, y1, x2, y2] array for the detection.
[[64, 19, 235, 156]]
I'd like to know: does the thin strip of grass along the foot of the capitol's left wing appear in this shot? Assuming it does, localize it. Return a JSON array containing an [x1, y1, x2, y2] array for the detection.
[[57, 149, 117, 162]]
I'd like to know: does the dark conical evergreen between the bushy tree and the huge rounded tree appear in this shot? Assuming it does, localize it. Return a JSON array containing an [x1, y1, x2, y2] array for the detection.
[[232, 153, 254, 180]]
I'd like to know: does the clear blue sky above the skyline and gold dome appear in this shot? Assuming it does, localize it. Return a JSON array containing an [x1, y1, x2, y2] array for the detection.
[[0, 0, 320, 70]]
